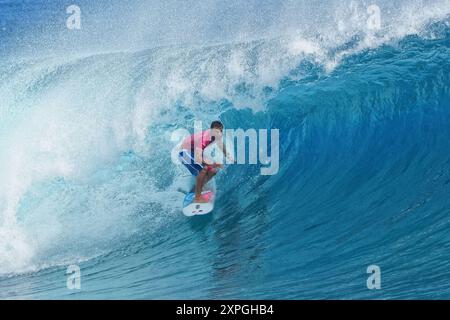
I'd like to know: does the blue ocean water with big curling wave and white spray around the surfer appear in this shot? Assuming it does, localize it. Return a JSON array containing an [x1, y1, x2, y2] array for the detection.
[[0, 0, 450, 299]]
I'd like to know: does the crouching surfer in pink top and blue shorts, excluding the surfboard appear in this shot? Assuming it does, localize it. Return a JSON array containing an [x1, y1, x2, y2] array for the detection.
[[179, 121, 233, 203]]
